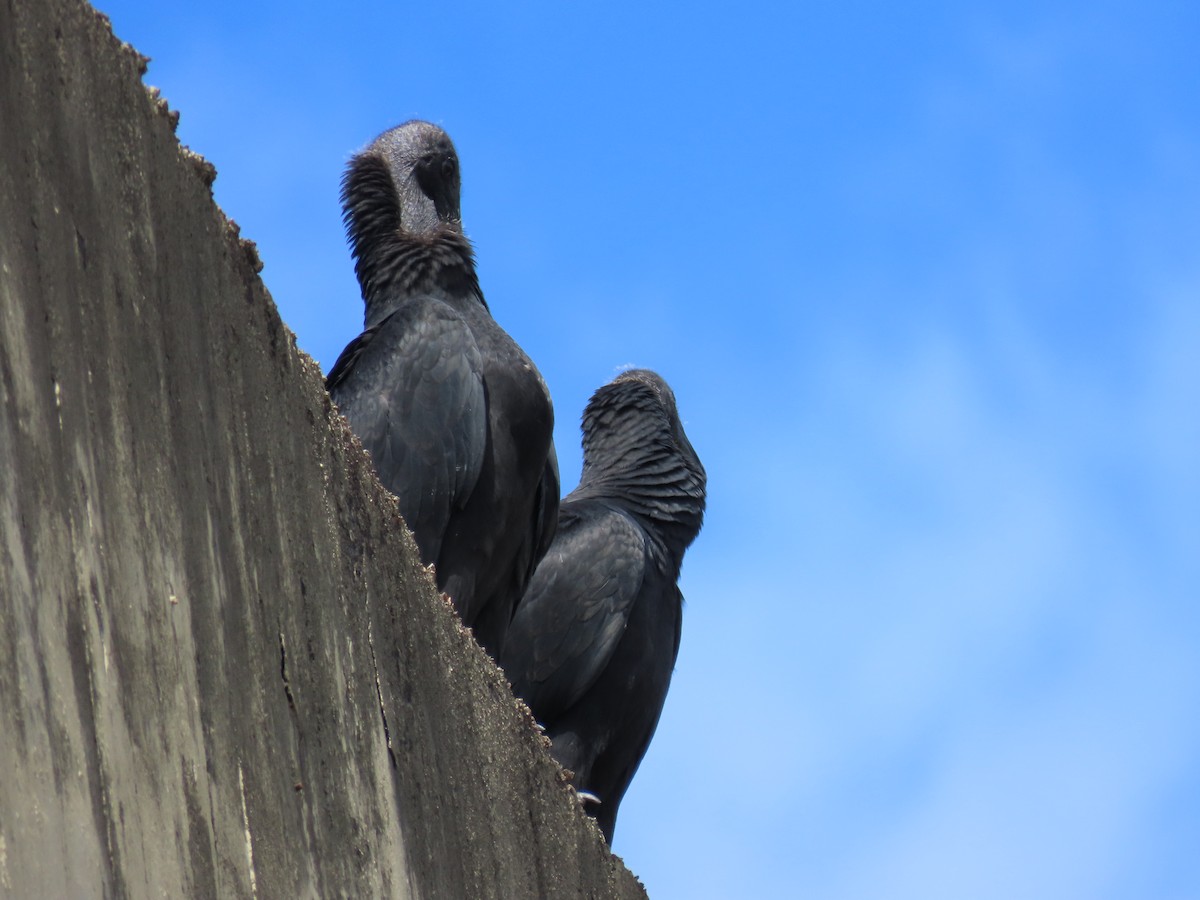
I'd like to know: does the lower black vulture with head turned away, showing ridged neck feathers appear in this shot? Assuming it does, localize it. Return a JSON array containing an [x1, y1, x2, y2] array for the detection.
[[502, 370, 706, 844]]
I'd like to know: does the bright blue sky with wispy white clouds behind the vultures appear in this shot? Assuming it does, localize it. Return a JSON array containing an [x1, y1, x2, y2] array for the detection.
[[101, 0, 1200, 900]]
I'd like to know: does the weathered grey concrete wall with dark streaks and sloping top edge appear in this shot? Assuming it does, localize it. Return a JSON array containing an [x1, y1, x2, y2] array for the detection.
[[0, 0, 643, 898]]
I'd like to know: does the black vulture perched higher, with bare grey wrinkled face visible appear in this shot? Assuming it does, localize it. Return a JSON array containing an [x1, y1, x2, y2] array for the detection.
[[325, 121, 558, 658]]
